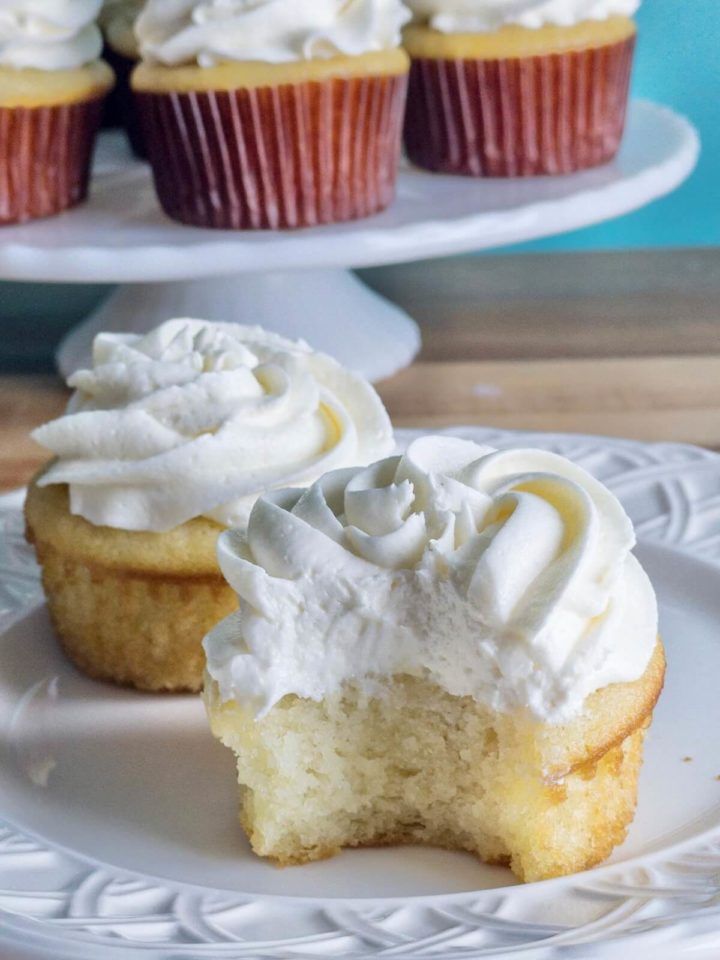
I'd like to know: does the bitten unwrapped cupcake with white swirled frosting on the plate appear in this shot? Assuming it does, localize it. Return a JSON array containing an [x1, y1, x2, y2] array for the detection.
[[205, 437, 665, 881]]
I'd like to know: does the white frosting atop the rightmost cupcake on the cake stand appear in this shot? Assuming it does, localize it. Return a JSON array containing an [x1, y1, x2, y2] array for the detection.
[[405, 0, 640, 33]]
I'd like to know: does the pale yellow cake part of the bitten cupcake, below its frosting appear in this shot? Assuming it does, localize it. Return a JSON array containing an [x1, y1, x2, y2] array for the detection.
[[205, 643, 664, 881]]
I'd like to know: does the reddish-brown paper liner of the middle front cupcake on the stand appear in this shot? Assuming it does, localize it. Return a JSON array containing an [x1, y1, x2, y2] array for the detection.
[[136, 76, 407, 230]]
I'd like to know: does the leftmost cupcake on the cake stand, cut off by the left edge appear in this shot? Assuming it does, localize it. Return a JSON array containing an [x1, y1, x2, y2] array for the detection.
[[0, 0, 113, 225]]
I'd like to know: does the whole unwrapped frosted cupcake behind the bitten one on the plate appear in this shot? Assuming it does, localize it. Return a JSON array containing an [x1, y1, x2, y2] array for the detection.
[[25, 320, 393, 691]]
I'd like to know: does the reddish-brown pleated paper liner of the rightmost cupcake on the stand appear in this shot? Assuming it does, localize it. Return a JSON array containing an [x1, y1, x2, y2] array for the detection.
[[404, 36, 635, 177]]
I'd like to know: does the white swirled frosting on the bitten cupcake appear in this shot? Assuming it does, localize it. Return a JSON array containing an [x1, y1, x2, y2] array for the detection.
[[204, 437, 657, 722]]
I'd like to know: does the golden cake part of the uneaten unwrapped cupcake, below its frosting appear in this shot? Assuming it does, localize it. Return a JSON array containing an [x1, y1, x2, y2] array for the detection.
[[25, 474, 237, 692]]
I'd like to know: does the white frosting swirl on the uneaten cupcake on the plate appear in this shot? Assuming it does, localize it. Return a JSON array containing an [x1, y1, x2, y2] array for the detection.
[[33, 320, 393, 532]]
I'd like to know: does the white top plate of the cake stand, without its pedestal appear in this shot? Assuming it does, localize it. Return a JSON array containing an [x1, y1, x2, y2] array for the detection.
[[0, 101, 699, 283]]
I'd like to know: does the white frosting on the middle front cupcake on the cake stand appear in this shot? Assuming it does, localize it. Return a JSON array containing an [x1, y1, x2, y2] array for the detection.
[[135, 0, 410, 67]]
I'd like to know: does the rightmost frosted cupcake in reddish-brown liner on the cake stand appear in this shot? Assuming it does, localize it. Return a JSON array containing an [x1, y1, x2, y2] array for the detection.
[[404, 0, 640, 177]]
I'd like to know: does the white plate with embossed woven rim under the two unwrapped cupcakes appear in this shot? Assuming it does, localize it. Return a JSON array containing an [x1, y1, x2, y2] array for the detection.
[[0, 428, 720, 960]]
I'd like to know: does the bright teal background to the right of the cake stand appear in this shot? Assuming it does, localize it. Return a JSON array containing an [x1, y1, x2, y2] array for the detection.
[[509, 0, 720, 251]]
